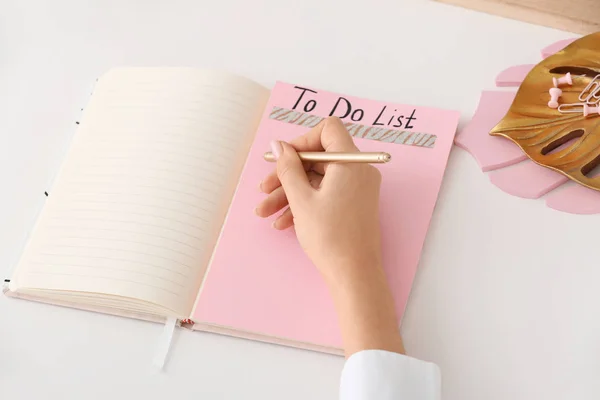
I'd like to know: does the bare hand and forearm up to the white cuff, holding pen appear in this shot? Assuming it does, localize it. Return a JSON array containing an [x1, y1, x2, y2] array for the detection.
[[256, 118, 404, 356]]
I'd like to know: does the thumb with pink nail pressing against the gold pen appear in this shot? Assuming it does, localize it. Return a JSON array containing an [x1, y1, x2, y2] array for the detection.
[[271, 140, 313, 203]]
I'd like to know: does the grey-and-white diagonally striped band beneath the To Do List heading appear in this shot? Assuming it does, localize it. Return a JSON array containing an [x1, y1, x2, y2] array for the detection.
[[269, 107, 437, 149]]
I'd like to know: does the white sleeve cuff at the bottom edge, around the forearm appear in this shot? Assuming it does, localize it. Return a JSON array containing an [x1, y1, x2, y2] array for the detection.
[[340, 350, 441, 400]]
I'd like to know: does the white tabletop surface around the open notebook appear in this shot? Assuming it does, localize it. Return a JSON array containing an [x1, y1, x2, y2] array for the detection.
[[0, 0, 600, 400]]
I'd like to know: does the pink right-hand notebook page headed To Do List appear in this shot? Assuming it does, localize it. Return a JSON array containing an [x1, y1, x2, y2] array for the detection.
[[193, 83, 459, 348]]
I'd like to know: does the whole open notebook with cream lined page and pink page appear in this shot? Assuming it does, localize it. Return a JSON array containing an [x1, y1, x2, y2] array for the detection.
[[5, 68, 459, 353]]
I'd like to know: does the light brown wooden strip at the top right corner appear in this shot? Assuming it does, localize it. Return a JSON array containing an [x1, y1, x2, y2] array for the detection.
[[434, 0, 600, 34]]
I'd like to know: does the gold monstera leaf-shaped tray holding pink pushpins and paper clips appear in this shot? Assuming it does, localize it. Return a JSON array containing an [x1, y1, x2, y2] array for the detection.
[[490, 32, 600, 191]]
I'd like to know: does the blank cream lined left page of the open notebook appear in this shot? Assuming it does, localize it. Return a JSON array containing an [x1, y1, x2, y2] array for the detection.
[[11, 68, 269, 316]]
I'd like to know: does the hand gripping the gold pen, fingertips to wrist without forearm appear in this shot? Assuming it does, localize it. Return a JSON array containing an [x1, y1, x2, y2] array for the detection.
[[256, 118, 381, 281]]
